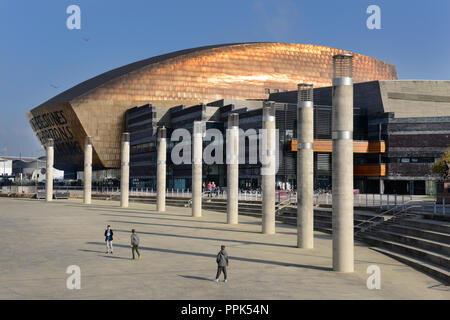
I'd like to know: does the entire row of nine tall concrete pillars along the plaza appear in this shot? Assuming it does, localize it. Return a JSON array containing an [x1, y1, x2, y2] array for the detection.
[[46, 54, 354, 272]]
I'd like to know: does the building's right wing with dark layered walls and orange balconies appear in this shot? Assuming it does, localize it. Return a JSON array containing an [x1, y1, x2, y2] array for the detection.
[[269, 80, 450, 194]]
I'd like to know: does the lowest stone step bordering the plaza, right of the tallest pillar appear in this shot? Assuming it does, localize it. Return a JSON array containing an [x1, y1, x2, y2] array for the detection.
[[370, 247, 450, 285]]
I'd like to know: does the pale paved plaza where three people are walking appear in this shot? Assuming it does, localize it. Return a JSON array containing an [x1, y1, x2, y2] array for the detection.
[[0, 198, 450, 300]]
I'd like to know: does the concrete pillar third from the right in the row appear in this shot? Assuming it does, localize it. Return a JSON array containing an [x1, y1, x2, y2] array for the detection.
[[260, 102, 276, 234]]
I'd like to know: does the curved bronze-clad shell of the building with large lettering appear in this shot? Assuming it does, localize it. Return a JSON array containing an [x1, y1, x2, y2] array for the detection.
[[27, 43, 397, 169]]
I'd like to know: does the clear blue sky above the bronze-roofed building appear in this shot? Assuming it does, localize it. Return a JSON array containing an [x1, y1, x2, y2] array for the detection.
[[0, 0, 450, 155]]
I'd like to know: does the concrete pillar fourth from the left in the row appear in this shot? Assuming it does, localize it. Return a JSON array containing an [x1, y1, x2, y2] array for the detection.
[[156, 127, 167, 212]]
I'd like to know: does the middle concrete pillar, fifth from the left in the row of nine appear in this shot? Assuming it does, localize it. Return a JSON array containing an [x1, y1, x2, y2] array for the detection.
[[192, 121, 205, 217]]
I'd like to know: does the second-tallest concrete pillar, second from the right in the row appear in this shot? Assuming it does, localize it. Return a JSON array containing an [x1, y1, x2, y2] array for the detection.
[[297, 84, 314, 249]]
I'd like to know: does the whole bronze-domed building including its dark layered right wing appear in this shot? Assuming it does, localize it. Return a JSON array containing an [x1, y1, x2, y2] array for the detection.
[[27, 43, 450, 194]]
